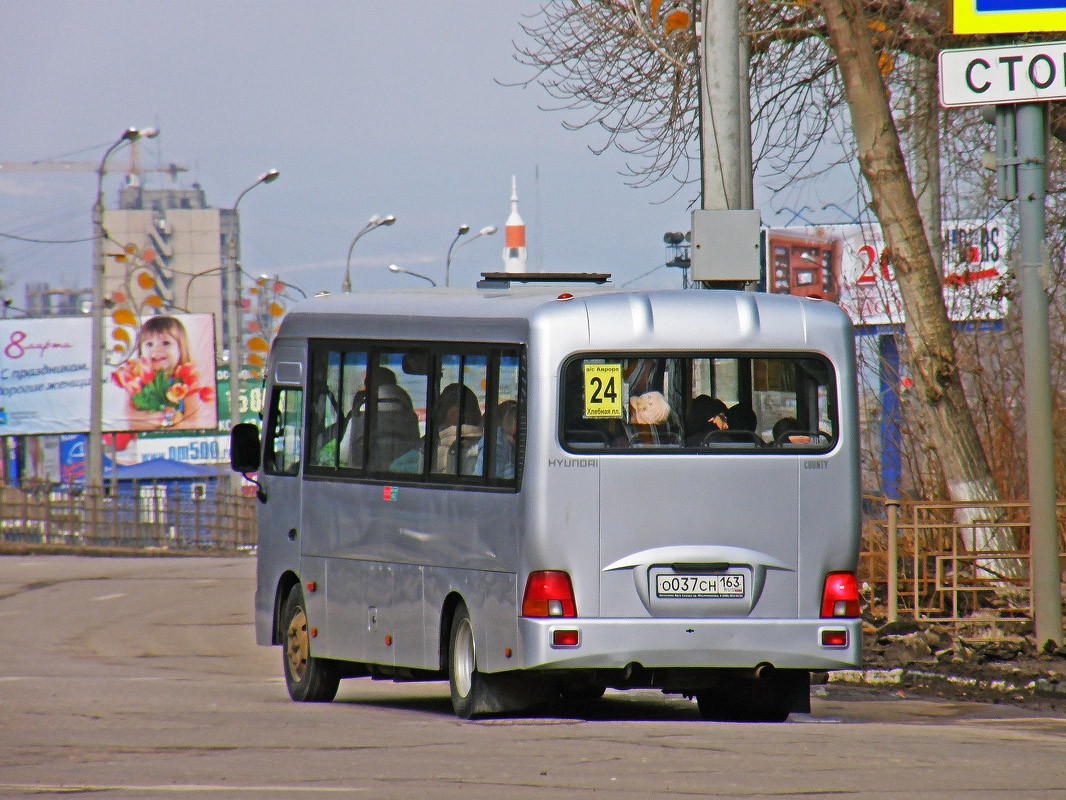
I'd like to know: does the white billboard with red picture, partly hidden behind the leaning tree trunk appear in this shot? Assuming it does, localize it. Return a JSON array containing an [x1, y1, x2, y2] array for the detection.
[[766, 219, 1008, 325]]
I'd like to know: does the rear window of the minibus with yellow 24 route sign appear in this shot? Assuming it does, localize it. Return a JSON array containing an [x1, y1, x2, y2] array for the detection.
[[561, 353, 838, 454]]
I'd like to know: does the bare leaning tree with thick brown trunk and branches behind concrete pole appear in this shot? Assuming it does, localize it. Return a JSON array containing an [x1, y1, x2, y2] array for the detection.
[[517, 0, 1066, 546]]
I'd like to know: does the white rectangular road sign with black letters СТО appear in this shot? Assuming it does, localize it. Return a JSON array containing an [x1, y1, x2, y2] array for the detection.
[[939, 42, 1066, 108]]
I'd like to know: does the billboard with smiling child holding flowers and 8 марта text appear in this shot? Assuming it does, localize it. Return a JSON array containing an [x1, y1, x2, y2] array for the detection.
[[0, 314, 217, 436]]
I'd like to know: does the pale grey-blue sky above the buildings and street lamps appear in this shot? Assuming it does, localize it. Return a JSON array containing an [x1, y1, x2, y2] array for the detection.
[[0, 0, 848, 305]]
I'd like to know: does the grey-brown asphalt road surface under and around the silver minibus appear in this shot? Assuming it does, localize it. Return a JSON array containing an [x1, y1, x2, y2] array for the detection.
[[0, 556, 1066, 800]]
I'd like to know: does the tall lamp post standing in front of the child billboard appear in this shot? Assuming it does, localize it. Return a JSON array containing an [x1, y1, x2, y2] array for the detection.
[[85, 128, 159, 491]]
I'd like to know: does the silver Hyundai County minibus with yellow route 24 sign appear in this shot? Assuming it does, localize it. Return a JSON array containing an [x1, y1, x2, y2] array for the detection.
[[231, 273, 860, 721]]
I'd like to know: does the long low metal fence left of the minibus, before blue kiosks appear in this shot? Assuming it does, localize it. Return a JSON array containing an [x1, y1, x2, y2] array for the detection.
[[0, 481, 256, 550]]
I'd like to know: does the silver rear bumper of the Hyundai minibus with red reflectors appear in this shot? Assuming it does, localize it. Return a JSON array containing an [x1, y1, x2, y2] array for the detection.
[[518, 618, 862, 670]]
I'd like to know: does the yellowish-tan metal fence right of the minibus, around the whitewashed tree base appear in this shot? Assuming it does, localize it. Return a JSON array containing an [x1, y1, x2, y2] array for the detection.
[[859, 498, 1066, 625]]
